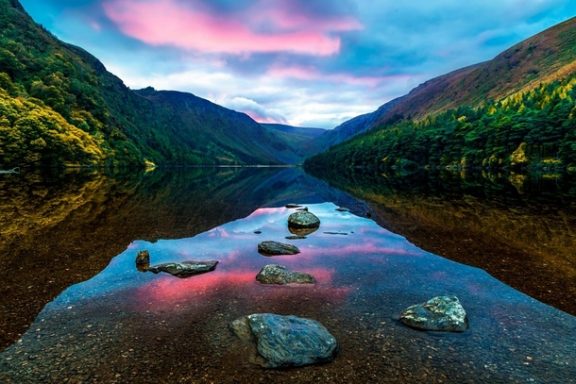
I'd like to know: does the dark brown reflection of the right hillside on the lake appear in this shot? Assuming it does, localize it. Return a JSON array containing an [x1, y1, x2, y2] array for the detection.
[[308, 170, 576, 314]]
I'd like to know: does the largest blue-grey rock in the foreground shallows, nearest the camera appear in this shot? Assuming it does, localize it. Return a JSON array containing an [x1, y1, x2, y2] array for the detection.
[[230, 313, 338, 368]]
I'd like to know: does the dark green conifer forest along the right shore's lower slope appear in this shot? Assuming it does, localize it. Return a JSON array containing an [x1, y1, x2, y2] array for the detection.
[[306, 75, 576, 168]]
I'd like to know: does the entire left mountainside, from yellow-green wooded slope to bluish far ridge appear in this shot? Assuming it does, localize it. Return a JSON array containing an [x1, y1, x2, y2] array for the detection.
[[0, 0, 301, 168]]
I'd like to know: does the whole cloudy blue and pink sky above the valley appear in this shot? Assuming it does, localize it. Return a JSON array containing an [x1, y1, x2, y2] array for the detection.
[[21, 0, 576, 128]]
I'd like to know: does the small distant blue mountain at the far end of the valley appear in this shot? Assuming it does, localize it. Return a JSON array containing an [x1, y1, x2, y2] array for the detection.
[[260, 123, 328, 164]]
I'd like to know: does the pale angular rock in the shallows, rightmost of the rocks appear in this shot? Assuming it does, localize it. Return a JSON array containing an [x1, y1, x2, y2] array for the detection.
[[400, 296, 468, 332]]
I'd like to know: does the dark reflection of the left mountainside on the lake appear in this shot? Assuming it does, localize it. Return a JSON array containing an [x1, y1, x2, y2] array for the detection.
[[0, 168, 368, 348]]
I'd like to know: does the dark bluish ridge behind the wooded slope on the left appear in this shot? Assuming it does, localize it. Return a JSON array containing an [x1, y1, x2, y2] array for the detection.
[[134, 88, 302, 164]]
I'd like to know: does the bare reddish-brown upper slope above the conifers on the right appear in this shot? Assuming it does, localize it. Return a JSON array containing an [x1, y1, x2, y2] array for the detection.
[[317, 18, 576, 149]]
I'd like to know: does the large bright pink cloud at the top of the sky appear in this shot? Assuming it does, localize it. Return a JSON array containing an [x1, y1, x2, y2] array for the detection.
[[103, 0, 360, 56]]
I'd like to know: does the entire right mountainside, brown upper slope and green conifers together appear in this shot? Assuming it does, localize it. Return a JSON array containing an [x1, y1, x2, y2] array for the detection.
[[307, 18, 576, 168]]
